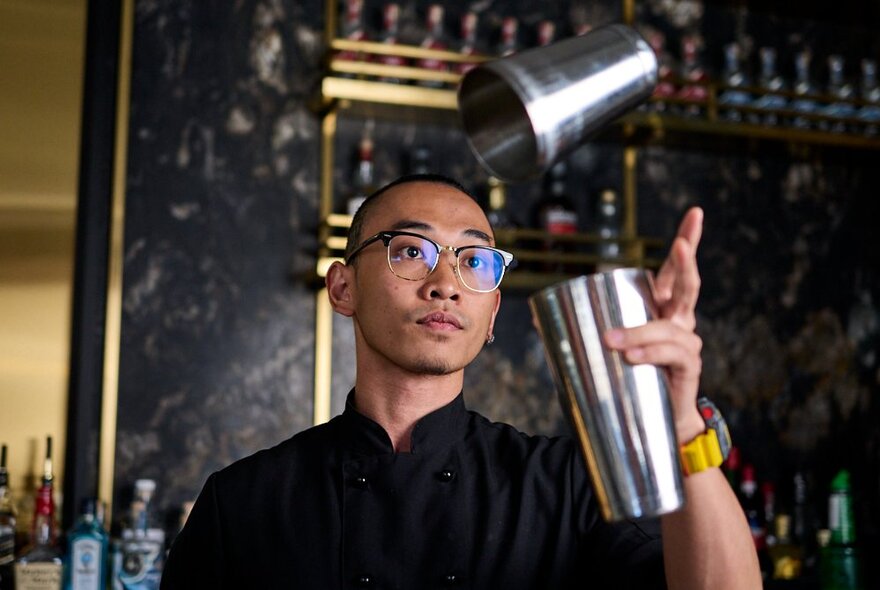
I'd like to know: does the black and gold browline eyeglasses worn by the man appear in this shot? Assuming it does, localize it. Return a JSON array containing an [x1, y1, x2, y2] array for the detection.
[[345, 231, 513, 293]]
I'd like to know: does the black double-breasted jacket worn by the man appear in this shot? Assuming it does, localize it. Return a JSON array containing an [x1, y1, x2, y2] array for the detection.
[[162, 393, 665, 590]]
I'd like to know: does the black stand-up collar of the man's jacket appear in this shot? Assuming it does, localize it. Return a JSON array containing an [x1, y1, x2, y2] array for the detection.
[[341, 389, 468, 455]]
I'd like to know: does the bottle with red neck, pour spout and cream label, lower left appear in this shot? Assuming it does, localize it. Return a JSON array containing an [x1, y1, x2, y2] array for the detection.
[[14, 436, 62, 590]]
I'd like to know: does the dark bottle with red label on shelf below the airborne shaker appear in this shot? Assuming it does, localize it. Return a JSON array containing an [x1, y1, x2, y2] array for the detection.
[[536, 161, 578, 272]]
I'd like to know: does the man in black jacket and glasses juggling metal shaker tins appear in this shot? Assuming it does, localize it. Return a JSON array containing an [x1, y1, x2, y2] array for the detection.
[[162, 175, 761, 589]]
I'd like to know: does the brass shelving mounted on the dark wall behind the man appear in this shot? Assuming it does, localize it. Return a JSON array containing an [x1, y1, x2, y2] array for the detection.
[[314, 19, 880, 424]]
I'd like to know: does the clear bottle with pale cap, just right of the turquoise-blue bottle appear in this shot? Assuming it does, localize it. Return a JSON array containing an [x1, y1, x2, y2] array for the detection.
[[113, 479, 165, 590]]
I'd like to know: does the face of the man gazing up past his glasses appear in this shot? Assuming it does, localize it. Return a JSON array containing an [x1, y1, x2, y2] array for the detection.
[[351, 182, 501, 375]]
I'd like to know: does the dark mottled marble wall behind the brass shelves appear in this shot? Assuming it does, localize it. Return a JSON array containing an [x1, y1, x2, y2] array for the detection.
[[116, 0, 880, 580]]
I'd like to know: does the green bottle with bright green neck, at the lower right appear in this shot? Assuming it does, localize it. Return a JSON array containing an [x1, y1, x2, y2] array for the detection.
[[821, 470, 862, 590]]
